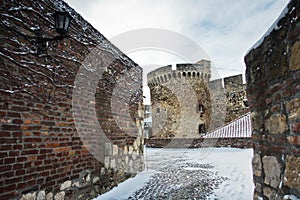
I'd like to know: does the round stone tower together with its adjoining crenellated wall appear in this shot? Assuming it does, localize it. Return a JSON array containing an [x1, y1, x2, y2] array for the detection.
[[147, 60, 248, 138]]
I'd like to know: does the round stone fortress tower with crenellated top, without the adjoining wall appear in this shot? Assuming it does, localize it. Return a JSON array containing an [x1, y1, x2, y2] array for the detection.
[[147, 60, 214, 138]]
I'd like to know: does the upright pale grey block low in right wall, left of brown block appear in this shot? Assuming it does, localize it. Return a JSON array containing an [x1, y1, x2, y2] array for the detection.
[[262, 156, 281, 188]]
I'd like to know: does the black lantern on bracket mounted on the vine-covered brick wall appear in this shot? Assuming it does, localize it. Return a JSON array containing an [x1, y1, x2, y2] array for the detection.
[[37, 11, 72, 54]]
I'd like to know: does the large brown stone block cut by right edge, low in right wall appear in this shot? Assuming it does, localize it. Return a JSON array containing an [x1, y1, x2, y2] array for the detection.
[[284, 155, 300, 192]]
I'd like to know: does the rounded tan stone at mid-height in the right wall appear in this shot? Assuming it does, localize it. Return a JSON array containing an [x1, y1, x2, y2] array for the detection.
[[265, 114, 288, 134]]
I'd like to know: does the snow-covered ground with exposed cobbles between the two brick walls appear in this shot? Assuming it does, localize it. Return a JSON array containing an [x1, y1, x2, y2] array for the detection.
[[94, 148, 254, 200]]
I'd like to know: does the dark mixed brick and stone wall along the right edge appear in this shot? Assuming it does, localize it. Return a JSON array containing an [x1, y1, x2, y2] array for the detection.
[[245, 0, 300, 200]]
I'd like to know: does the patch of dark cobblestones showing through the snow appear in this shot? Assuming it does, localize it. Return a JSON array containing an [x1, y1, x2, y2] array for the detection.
[[128, 149, 227, 200]]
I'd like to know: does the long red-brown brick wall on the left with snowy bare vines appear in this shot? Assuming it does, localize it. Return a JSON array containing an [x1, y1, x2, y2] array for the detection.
[[0, 0, 143, 199]]
